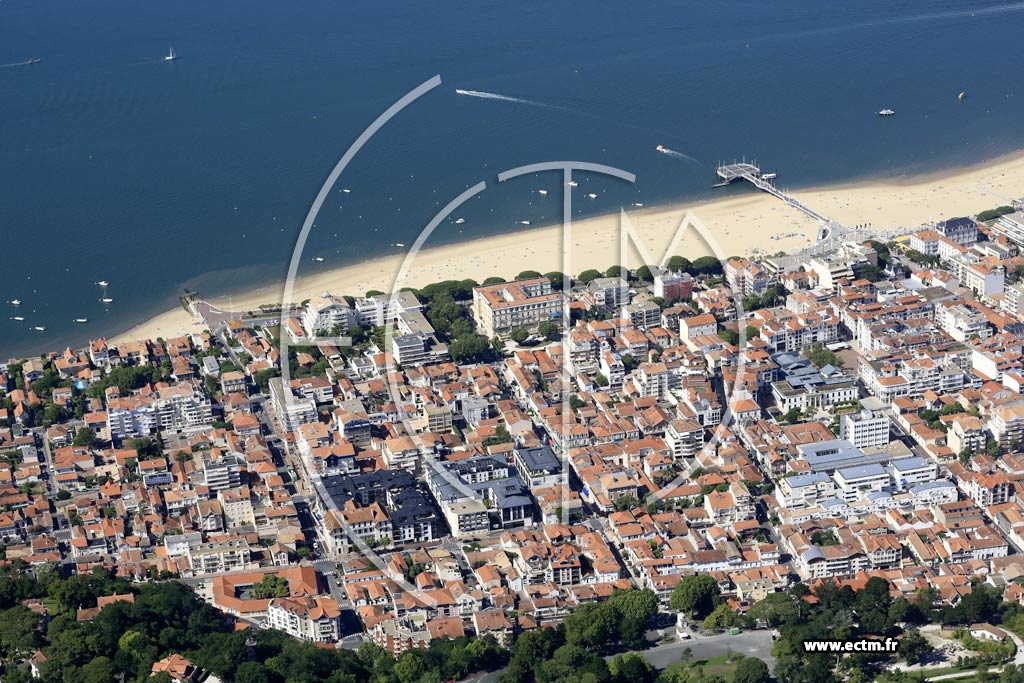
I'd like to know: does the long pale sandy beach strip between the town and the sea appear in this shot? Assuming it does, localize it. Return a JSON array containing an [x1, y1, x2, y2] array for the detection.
[[113, 153, 1024, 342]]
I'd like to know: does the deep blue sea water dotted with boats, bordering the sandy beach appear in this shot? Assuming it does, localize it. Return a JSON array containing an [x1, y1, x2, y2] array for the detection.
[[0, 0, 1024, 357]]
